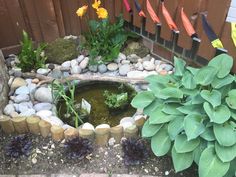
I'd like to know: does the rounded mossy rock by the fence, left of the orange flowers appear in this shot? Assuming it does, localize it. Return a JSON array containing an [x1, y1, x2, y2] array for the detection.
[[45, 38, 79, 64]]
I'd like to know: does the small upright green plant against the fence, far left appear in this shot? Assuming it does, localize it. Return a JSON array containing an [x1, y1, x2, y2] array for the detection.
[[18, 31, 47, 72]]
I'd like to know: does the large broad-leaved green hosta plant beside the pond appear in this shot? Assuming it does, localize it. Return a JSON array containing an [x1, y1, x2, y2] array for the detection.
[[132, 54, 236, 177]]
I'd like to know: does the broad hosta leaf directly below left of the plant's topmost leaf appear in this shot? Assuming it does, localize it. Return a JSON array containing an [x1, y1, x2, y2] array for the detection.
[[194, 66, 217, 86]]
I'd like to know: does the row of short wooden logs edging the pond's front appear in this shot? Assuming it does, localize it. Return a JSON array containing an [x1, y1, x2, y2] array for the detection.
[[0, 115, 144, 147]]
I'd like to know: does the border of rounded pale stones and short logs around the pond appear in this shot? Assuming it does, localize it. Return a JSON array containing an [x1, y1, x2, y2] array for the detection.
[[0, 54, 173, 146]]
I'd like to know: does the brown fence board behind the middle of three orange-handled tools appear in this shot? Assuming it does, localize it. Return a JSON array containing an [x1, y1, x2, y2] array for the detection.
[[158, 0, 178, 41]]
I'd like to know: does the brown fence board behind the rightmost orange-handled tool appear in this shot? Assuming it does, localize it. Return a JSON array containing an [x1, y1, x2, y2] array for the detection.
[[176, 0, 201, 49]]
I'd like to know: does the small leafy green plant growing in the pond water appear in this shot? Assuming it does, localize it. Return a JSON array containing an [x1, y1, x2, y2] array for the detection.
[[103, 90, 129, 110]]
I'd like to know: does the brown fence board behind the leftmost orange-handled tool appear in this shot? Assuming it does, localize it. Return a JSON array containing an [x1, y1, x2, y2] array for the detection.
[[145, 0, 160, 34]]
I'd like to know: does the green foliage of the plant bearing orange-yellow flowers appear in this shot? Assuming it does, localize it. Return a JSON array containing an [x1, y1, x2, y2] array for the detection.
[[83, 17, 136, 64]]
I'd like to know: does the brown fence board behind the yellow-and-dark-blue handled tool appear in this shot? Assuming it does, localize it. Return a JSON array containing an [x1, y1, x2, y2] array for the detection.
[[198, 0, 231, 60]]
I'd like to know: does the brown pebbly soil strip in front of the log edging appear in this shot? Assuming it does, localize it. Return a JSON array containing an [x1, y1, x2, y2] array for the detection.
[[0, 130, 198, 177]]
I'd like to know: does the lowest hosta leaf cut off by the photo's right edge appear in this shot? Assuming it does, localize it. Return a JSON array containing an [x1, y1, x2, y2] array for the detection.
[[215, 142, 236, 162]]
